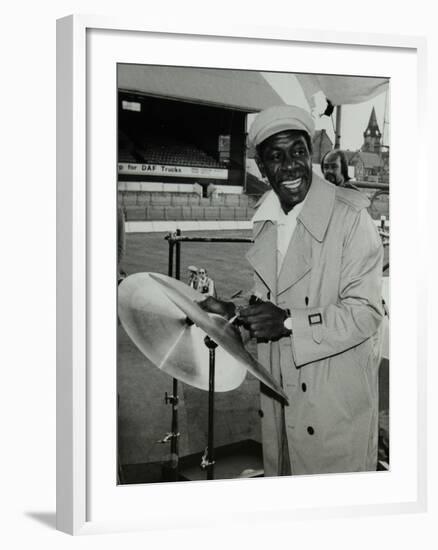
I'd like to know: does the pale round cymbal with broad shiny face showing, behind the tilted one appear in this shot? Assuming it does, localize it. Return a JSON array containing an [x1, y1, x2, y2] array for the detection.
[[118, 273, 246, 392]]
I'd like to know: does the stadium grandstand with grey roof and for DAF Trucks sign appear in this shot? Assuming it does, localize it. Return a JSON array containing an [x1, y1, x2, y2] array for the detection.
[[118, 64, 284, 227]]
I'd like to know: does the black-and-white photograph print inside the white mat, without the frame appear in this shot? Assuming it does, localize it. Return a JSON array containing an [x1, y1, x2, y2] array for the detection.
[[114, 64, 391, 485]]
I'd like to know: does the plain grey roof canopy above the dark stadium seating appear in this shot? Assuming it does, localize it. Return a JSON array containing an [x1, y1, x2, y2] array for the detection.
[[118, 64, 284, 113]]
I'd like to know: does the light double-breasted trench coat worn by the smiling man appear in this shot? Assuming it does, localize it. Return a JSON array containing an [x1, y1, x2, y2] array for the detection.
[[247, 174, 383, 476]]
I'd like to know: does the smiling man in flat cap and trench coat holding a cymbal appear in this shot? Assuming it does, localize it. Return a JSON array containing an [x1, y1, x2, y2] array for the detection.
[[202, 106, 383, 476]]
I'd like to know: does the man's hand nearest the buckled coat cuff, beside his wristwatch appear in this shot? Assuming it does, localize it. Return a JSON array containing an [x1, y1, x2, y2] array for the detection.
[[238, 302, 291, 342]]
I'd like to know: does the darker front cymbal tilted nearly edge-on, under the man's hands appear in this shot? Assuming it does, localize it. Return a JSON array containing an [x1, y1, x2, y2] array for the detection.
[[150, 273, 288, 403]]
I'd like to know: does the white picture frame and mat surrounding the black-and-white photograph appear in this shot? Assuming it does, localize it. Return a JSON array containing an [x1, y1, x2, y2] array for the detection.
[[57, 16, 427, 534]]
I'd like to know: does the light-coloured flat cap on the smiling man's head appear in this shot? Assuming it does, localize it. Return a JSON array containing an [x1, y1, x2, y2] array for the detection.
[[247, 105, 315, 158]]
